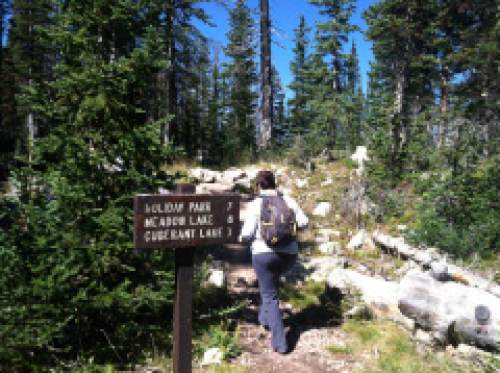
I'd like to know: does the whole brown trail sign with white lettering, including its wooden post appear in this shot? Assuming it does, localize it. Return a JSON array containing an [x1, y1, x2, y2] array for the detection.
[[134, 184, 240, 373]]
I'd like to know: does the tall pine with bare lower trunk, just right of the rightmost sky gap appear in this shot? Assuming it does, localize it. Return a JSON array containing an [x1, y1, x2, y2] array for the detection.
[[364, 0, 434, 173]]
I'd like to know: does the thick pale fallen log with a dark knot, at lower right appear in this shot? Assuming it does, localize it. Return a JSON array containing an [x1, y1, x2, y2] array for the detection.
[[327, 268, 500, 351]]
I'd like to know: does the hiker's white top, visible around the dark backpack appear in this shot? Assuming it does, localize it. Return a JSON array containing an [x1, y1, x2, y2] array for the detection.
[[240, 189, 309, 255]]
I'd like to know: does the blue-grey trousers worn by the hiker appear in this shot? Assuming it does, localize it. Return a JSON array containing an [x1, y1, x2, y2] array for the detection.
[[252, 252, 297, 352]]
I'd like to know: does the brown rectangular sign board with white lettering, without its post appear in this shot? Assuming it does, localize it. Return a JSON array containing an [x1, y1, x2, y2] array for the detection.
[[134, 193, 240, 249]]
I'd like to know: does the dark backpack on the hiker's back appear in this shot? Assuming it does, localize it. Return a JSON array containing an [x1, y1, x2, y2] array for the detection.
[[260, 195, 297, 247]]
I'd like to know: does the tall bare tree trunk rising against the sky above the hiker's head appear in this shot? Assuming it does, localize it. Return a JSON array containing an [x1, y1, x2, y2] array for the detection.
[[259, 0, 273, 149]]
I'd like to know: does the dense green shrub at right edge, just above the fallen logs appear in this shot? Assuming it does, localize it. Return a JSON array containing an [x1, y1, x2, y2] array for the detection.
[[410, 157, 500, 257]]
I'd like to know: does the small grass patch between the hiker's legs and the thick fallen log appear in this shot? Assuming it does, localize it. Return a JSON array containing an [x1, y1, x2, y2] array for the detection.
[[280, 281, 326, 310]]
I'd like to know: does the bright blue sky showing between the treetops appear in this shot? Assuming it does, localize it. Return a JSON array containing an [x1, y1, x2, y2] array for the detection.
[[197, 0, 376, 97]]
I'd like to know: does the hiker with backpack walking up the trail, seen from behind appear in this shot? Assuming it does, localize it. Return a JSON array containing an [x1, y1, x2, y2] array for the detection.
[[240, 171, 309, 354]]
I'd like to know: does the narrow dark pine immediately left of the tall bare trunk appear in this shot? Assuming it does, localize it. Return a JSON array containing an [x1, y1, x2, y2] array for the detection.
[[224, 0, 257, 160]]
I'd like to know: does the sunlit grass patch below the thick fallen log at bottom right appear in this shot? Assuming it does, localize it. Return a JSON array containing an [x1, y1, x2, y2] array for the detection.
[[327, 320, 480, 373]]
